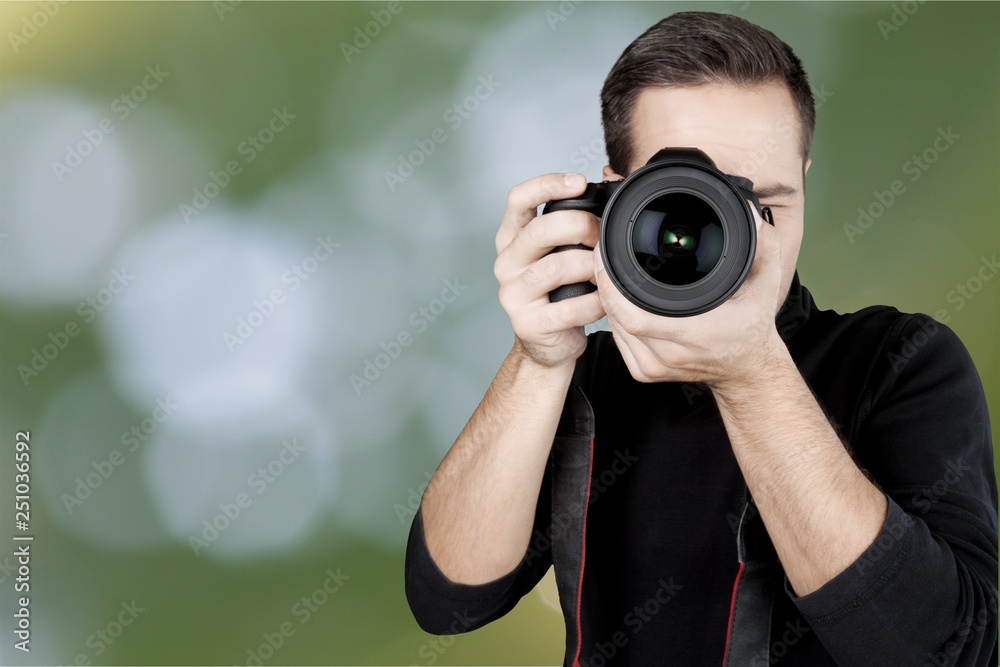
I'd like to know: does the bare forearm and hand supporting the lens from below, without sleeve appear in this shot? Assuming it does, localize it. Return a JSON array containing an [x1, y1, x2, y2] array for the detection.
[[595, 210, 886, 594]]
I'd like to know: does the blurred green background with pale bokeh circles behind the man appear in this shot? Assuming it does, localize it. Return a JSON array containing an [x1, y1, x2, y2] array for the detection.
[[0, 2, 1000, 665]]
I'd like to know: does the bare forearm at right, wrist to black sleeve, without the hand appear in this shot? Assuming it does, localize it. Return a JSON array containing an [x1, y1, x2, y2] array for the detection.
[[713, 341, 887, 596]]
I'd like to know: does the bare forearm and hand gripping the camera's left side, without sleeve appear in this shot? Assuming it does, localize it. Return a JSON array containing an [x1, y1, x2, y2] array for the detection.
[[404, 174, 604, 584]]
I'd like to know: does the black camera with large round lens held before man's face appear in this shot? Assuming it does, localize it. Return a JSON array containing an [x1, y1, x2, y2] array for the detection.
[[542, 148, 773, 317]]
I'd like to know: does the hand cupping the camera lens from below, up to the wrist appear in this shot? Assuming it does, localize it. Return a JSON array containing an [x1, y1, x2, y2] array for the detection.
[[594, 206, 784, 388]]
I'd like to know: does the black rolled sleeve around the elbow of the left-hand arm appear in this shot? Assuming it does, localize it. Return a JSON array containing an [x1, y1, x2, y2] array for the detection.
[[406, 470, 552, 635]]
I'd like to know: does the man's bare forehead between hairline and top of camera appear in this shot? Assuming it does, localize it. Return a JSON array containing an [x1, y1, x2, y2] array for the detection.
[[629, 83, 802, 180]]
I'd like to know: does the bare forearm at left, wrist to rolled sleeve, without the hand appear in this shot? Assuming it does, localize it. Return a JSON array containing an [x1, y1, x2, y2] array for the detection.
[[421, 345, 573, 584]]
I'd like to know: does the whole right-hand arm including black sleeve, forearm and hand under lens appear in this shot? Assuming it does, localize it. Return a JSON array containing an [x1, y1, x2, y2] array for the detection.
[[597, 218, 997, 667]]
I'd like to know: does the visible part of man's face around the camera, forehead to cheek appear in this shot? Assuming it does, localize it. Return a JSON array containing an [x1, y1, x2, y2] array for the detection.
[[604, 83, 809, 308]]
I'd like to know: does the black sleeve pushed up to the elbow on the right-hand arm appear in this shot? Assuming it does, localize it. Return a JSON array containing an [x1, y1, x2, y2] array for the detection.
[[786, 315, 997, 667]]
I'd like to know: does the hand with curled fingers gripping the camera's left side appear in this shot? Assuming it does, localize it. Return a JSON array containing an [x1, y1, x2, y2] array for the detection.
[[493, 174, 604, 367]]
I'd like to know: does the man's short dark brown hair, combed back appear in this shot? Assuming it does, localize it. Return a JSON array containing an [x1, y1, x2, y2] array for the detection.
[[601, 12, 816, 176]]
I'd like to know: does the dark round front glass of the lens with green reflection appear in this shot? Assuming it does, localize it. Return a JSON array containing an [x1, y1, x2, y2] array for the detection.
[[632, 192, 725, 285]]
